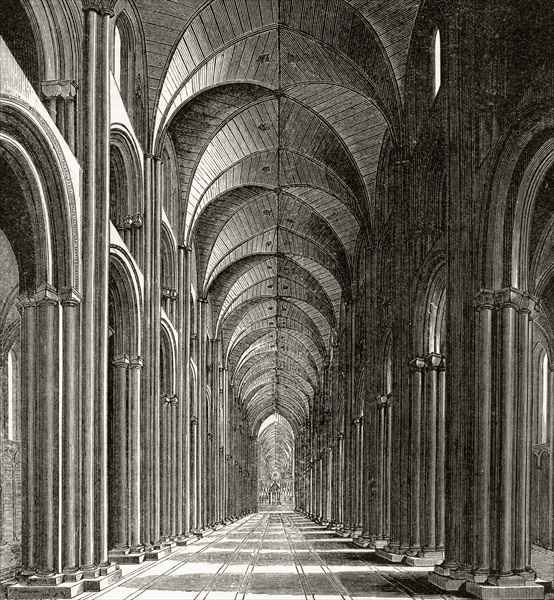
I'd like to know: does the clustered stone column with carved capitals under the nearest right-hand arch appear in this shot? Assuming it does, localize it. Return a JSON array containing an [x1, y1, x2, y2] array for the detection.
[[430, 288, 544, 598]]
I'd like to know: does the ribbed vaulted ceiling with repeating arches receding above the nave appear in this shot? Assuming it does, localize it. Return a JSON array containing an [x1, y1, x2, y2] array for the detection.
[[153, 0, 419, 478]]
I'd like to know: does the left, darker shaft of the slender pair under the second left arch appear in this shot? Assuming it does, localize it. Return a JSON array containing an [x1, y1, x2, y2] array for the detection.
[[110, 354, 129, 549]]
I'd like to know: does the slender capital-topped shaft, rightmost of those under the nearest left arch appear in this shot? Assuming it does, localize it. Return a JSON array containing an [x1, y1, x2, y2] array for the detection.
[[61, 289, 81, 577]]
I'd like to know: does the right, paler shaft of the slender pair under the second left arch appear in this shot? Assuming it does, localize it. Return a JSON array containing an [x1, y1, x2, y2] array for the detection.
[[127, 356, 142, 553]]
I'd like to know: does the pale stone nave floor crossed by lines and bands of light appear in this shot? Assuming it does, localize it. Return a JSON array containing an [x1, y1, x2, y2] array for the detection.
[[79, 511, 452, 600]]
